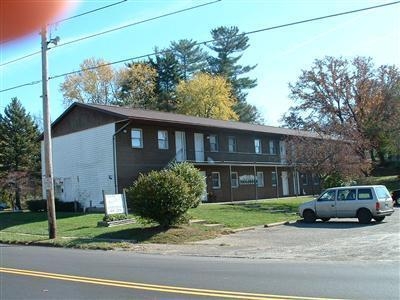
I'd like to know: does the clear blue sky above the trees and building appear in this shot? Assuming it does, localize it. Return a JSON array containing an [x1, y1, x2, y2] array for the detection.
[[0, 0, 400, 126]]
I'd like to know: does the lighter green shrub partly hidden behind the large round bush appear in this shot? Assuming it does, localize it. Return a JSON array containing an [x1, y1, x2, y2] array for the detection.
[[169, 162, 206, 208]]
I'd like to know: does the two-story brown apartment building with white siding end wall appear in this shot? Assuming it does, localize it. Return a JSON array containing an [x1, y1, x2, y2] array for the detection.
[[42, 103, 319, 207]]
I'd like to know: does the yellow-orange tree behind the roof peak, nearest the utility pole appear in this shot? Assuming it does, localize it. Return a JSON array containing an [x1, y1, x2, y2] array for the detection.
[[60, 58, 117, 106]]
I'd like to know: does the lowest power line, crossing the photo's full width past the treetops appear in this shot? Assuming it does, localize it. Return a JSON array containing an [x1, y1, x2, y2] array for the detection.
[[0, 0, 400, 93]]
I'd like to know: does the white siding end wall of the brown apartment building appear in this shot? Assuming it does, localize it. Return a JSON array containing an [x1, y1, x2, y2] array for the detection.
[[42, 124, 115, 207]]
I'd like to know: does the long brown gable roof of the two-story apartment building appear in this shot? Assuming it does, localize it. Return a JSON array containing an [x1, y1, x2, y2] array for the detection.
[[52, 102, 319, 138]]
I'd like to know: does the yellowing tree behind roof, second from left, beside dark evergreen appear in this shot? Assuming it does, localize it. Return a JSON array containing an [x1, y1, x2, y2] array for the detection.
[[117, 62, 157, 109]]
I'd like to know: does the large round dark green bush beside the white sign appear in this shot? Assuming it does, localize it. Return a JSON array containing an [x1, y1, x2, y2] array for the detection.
[[126, 170, 194, 228]]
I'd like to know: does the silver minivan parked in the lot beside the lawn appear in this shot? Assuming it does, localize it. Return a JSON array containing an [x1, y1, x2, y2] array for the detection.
[[299, 185, 394, 224]]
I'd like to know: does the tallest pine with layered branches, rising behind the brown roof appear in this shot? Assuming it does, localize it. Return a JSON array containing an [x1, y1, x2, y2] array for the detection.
[[208, 26, 259, 123]]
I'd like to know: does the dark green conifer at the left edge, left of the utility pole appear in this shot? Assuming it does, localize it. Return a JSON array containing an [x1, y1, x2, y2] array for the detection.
[[0, 98, 40, 209]]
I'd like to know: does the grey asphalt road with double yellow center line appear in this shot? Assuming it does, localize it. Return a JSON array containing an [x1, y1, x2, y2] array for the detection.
[[0, 245, 400, 299]]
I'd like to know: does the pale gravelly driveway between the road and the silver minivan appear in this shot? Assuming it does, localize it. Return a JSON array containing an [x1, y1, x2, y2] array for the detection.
[[129, 208, 400, 261]]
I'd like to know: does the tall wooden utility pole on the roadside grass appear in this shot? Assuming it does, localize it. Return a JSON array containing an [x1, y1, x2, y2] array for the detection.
[[40, 25, 57, 239]]
